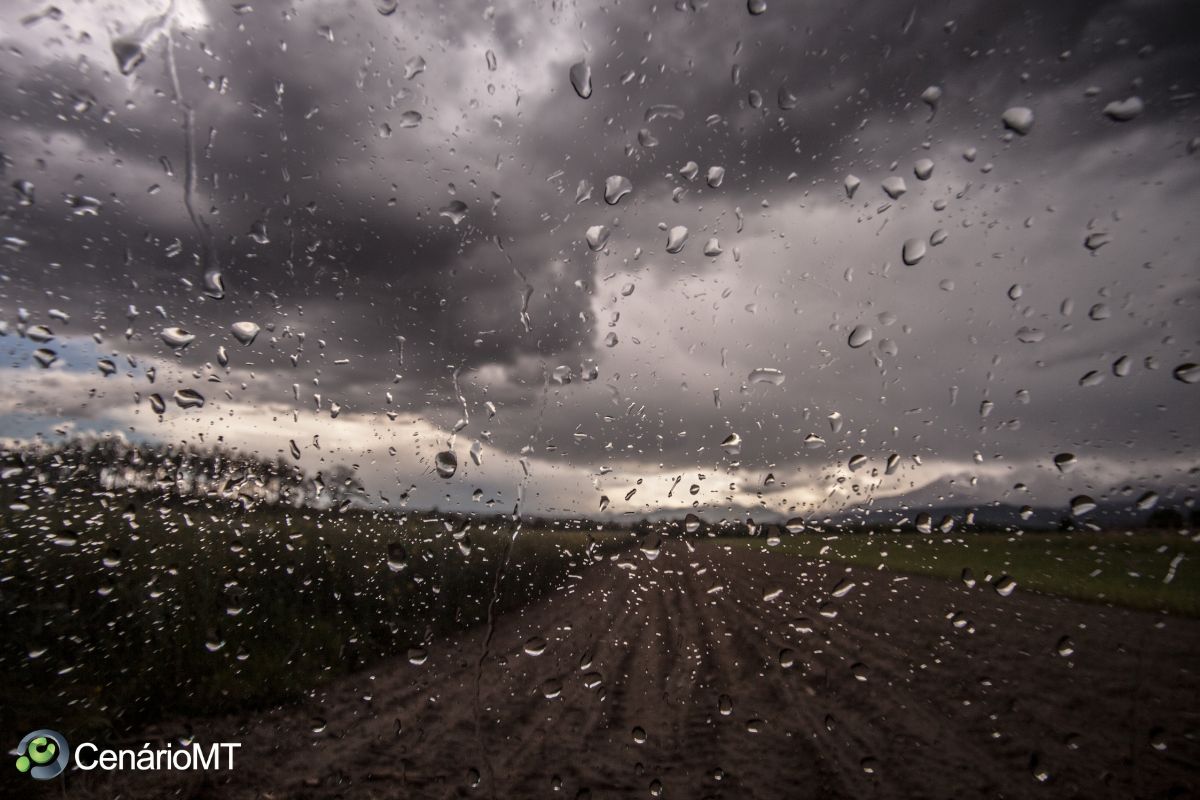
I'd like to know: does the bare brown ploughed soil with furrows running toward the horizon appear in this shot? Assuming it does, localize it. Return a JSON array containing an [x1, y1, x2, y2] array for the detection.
[[67, 542, 1200, 800]]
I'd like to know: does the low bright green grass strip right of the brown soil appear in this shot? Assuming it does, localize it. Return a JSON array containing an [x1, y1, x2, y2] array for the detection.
[[730, 531, 1200, 616]]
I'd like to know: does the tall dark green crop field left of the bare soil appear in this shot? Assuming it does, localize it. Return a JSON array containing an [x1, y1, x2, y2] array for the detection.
[[0, 492, 632, 736]]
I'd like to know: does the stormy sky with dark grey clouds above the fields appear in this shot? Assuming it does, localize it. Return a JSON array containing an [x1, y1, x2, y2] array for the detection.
[[0, 0, 1200, 518]]
